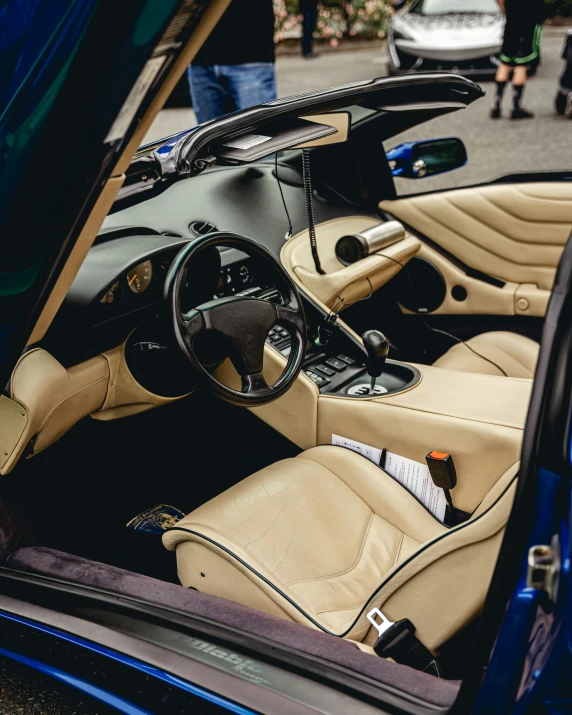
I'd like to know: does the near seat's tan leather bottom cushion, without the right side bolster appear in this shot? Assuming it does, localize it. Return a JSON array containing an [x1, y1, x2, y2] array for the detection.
[[163, 446, 445, 631]]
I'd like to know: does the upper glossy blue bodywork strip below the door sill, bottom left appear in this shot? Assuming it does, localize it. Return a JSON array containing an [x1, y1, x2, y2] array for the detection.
[[0, 610, 255, 715]]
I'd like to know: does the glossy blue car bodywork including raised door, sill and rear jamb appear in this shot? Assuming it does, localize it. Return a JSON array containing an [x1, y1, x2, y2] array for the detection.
[[0, 0, 572, 715]]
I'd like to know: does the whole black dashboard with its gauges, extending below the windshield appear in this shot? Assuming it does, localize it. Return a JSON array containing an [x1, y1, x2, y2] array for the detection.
[[43, 163, 366, 366]]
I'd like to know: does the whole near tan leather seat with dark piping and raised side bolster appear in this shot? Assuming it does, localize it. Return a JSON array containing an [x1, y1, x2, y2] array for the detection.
[[163, 446, 518, 650]]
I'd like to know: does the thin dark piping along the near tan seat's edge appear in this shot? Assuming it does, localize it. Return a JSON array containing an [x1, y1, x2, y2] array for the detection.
[[165, 474, 518, 638]]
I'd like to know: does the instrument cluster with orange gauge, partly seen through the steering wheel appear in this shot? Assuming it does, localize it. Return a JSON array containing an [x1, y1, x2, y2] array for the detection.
[[46, 229, 278, 364]]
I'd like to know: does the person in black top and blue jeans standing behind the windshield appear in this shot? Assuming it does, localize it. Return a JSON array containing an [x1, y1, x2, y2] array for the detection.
[[187, 0, 277, 124]]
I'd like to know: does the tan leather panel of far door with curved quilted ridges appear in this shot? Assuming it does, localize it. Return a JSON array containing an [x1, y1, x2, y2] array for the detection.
[[380, 182, 572, 316]]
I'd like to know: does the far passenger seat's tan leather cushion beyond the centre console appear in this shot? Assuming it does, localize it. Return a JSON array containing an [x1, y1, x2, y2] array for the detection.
[[433, 330, 540, 378]]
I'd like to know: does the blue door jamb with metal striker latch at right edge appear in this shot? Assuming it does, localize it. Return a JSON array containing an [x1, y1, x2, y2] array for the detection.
[[456, 231, 572, 715]]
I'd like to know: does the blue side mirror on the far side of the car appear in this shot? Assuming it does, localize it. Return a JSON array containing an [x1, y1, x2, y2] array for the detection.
[[386, 137, 468, 179]]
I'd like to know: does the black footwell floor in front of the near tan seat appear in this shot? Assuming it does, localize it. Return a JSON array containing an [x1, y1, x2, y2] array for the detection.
[[11, 390, 300, 583]]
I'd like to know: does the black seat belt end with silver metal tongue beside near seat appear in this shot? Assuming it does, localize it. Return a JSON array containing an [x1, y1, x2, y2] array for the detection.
[[367, 608, 442, 678]]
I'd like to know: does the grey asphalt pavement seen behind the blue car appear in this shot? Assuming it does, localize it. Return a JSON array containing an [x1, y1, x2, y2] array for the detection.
[[147, 29, 572, 193]]
